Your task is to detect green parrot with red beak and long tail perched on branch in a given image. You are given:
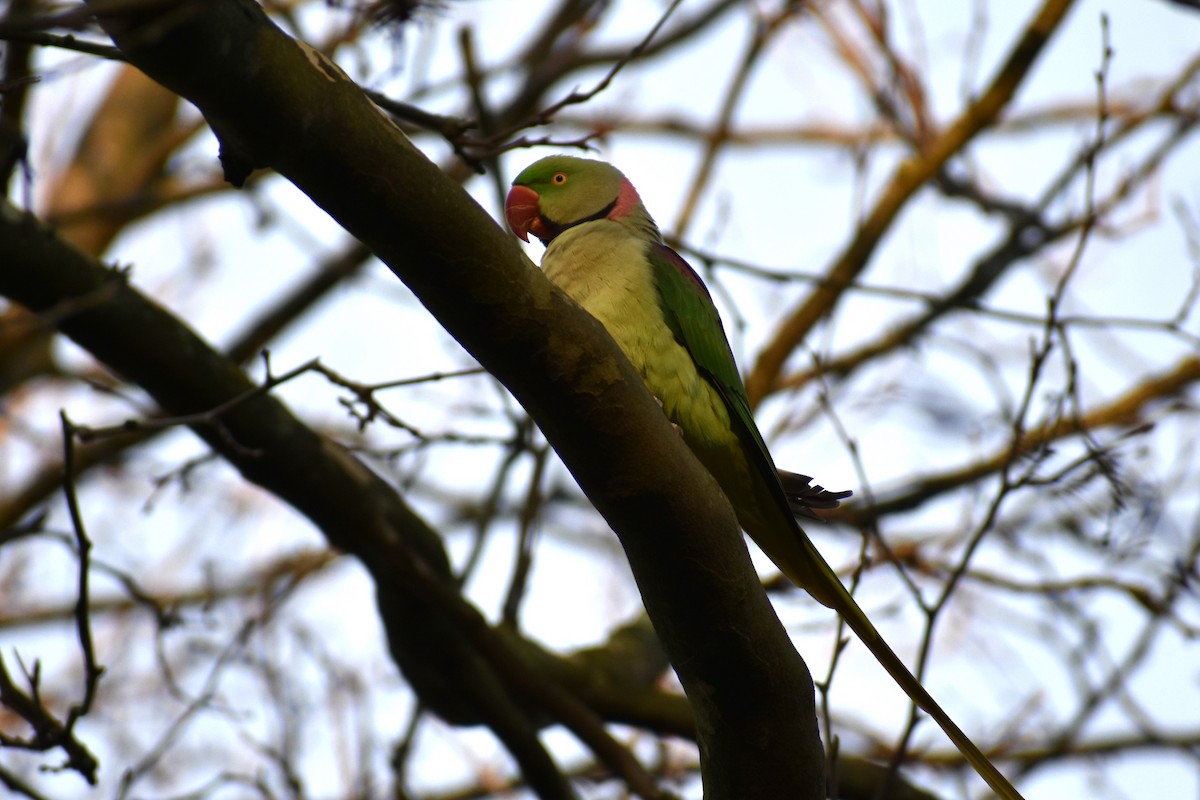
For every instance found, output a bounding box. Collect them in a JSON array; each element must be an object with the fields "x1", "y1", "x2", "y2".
[{"x1": 504, "y1": 155, "x2": 1021, "y2": 800}]
